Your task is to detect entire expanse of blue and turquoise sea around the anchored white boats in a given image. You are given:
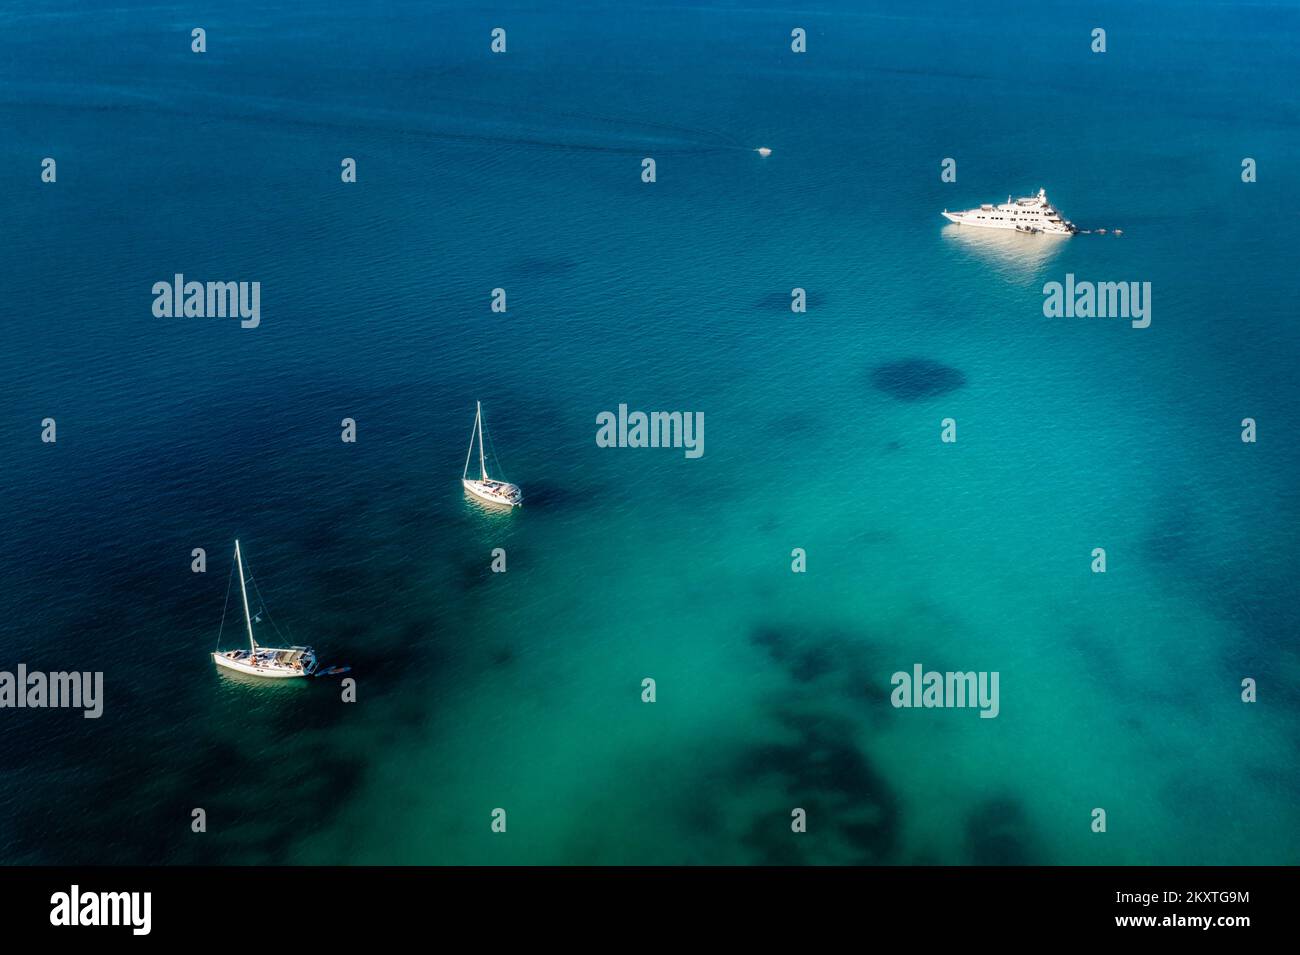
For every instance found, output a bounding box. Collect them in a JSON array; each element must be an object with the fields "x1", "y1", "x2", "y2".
[{"x1": 0, "y1": 4, "x2": 1300, "y2": 864}]
